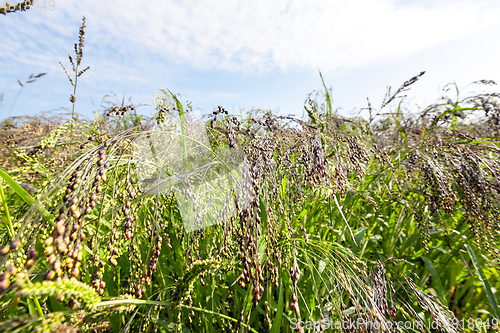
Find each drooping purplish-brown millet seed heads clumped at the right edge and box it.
[409,131,500,259]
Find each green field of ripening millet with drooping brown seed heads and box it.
[0,9,500,333]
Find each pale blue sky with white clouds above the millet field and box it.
[0,0,500,119]
